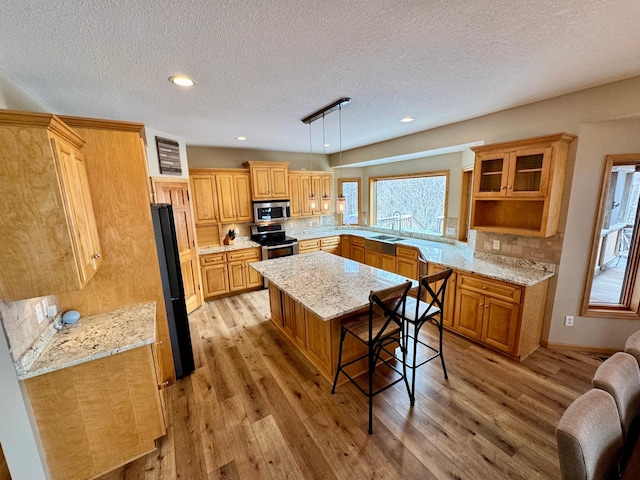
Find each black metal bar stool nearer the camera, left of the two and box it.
[331,281,411,434]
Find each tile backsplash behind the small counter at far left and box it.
[0,295,59,360]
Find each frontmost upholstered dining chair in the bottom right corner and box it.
[556,389,622,480]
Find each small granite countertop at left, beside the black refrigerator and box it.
[16,302,156,380]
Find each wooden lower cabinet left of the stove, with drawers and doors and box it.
[200,248,262,298]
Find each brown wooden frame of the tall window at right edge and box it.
[580,153,640,320]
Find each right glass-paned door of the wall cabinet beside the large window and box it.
[506,147,551,198]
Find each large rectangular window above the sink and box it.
[369,172,449,235]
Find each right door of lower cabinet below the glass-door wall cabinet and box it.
[482,297,519,353]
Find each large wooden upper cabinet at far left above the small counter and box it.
[0,110,102,301]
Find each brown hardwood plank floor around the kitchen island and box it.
[101,290,600,480]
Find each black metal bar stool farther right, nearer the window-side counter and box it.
[403,268,453,405]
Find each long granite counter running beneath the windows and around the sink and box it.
[292,228,555,287]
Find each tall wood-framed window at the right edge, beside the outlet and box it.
[582,154,640,319]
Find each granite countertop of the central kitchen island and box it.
[249,252,417,320]
